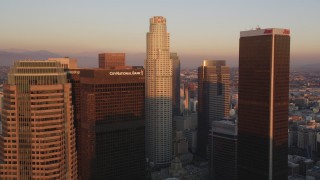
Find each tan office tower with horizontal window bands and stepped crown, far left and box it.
[0,60,77,180]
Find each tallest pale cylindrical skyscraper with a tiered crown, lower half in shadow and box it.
[145,16,173,166]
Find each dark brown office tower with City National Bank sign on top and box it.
[79,67,145,180]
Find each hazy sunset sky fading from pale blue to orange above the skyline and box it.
[0,0,320,64]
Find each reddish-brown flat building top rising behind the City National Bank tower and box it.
[99,53,126,69]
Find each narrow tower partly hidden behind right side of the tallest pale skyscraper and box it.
[170,53,181,115]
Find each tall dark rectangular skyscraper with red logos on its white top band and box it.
[238,28,290,180]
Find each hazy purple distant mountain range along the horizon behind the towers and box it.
[0,49,320,72]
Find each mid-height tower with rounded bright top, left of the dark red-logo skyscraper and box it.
[198,60,230,159]
